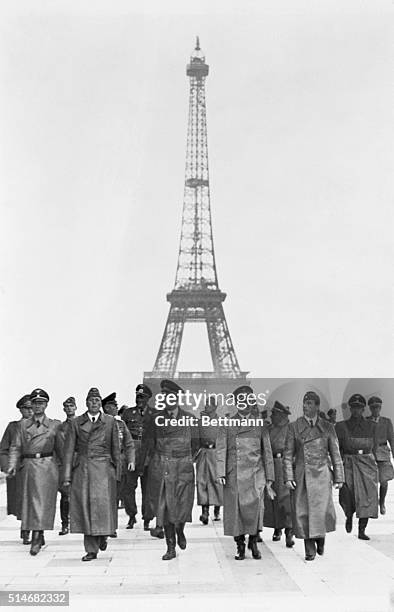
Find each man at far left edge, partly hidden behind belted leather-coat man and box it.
[0,395,33,544]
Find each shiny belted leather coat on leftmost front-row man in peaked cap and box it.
[8,415,62,531]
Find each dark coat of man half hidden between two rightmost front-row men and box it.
[264,423,292,529]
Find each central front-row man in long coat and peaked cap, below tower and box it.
[147,380,197,561]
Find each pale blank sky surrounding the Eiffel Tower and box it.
[0,0,394,421]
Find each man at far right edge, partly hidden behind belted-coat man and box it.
[367,396,394,514]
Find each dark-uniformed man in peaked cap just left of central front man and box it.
[122,384,154,531]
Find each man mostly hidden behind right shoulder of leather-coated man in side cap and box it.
[102,393,135,524]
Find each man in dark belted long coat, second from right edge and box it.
[336,393,379,540]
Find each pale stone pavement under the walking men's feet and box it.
[0,484,394,612]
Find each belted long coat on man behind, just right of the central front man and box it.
[196,411,223,506]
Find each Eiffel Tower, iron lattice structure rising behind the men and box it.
[151,37,246,378]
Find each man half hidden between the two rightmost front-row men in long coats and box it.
[264,401,294,548]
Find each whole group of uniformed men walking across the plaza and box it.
[0,380,394,561]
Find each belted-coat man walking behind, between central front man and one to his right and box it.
[196,397,223,525]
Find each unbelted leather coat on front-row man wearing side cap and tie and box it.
[63,412,120,536]
